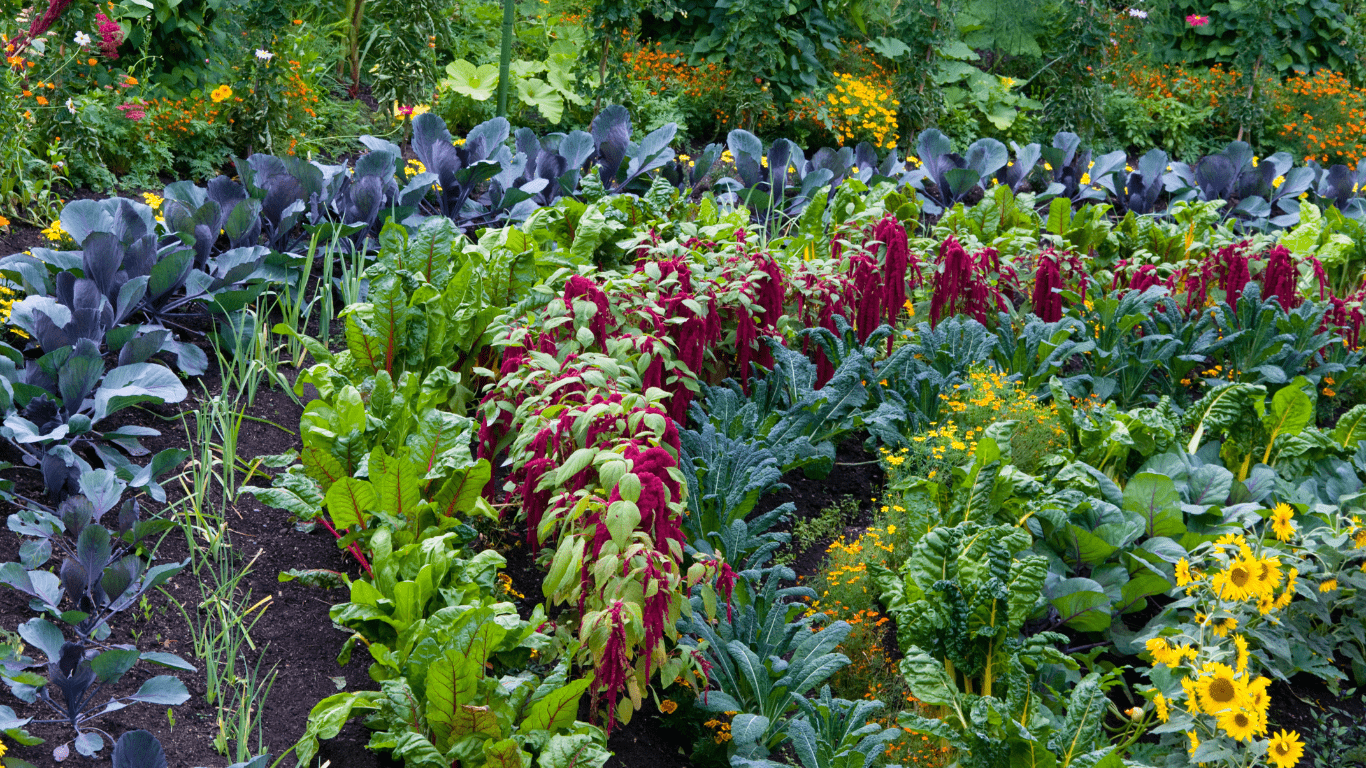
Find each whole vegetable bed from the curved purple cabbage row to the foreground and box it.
[0,3,1366,768]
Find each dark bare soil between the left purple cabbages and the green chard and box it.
[0,319,393,768]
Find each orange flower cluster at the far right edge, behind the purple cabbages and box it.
[1272,70,1366,167]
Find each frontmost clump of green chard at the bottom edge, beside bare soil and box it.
[304,532,608,768]
